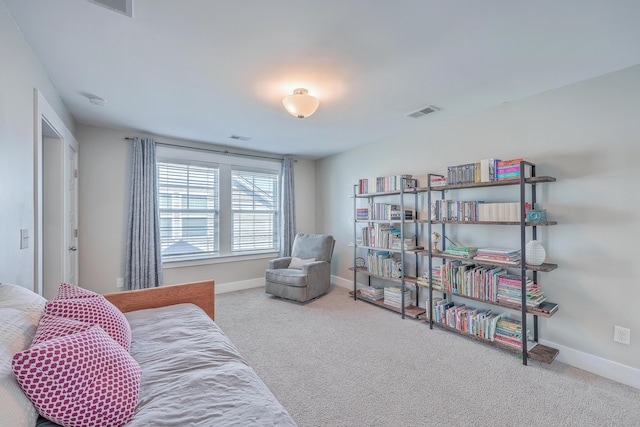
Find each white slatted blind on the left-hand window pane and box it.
[157,162,219,260]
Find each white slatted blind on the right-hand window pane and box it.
[231,170,279,253]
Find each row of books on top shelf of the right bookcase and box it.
[444,158,523,187]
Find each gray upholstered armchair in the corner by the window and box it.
[265,233,335,302]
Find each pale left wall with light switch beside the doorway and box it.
[0,2,75,289]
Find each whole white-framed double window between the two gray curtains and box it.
[157,147,280,261]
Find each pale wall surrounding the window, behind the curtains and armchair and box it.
[78,125,315,293]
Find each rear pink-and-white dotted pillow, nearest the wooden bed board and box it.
[44,295,131,351]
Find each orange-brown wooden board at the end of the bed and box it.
[104,280,215,320]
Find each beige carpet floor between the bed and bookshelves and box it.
[216,287,640,427]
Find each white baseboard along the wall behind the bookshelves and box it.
[331,276,640,389]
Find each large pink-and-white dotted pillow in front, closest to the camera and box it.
[12,326,142,427]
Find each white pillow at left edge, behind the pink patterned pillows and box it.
[0,283,46,426]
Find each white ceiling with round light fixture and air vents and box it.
[0,0,640,158]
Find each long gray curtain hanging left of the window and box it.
[124,138,162,289]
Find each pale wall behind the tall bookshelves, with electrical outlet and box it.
[316,66,640,387]
